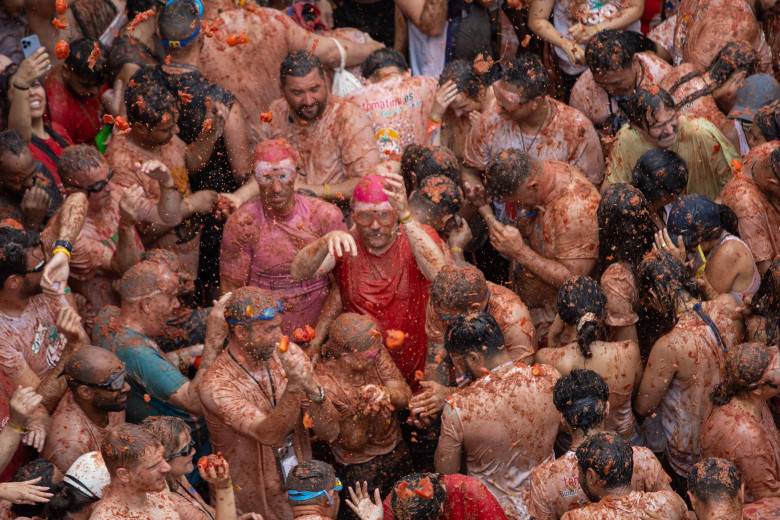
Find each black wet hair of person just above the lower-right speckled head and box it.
[553,368,609,433]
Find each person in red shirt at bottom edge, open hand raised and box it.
[347,473,507,520]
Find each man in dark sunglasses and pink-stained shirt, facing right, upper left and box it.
[57,144,146,324]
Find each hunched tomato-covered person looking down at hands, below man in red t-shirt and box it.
[317,313,413,495]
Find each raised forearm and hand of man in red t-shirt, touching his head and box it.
[382,173,446,281]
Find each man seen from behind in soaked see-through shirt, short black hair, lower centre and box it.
[436,312,560,519]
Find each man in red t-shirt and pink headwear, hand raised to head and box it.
[290,174,444,391]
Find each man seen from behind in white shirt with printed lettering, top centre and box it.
[346,49,436,153]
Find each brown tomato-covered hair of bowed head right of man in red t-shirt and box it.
[429,265,488,312]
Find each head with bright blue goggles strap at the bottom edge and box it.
[287,459,343,520]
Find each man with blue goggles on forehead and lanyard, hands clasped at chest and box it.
[200,287,338,520]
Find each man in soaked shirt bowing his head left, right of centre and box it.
[470,150,599,341]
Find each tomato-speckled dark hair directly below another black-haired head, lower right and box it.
[576,432,634,489]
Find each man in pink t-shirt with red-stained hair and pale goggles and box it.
[220,139,347,346]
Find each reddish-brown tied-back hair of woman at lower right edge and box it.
[710,343,774,406]
